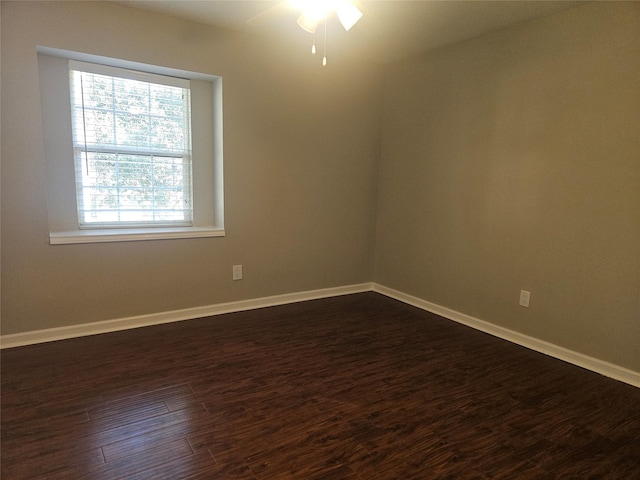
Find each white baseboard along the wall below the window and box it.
[0,283,373,349]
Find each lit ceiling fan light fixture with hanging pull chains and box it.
[290,0,362,65]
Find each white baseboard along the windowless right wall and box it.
[373,283,640,387]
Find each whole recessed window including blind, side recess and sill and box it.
[38,47,225,244]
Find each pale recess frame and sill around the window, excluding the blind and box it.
[38,47,225,245]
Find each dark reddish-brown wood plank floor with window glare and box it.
[1,293,640,480]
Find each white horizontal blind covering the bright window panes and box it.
[69,61,193,228]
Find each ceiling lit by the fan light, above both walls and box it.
[119,0,582,63]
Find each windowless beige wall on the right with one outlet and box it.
[374,2,640,371]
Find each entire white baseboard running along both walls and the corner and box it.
[0,283,640,388]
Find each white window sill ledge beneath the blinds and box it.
[49,227,225,245]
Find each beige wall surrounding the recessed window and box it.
[2,1,381,335]
